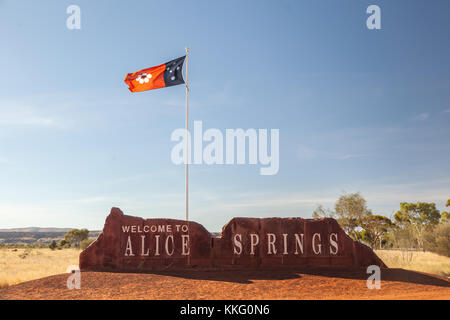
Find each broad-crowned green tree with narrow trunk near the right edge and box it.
[394,202,441,249]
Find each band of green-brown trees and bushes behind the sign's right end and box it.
[313,193,450,259]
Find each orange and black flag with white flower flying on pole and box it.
[125,56,186,92]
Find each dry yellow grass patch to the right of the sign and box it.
[375,250,450,277]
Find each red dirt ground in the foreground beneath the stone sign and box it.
[0,267,450,300]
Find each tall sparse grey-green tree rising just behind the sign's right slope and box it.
[334,192,371,239]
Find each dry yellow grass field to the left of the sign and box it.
[0,249,80,288]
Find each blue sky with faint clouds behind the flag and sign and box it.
[0,0,450,231]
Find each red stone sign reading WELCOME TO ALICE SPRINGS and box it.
[80,208,386,271]
